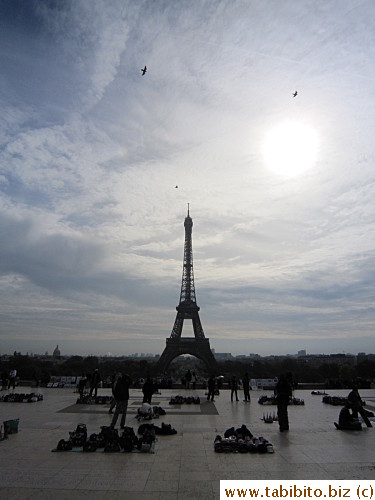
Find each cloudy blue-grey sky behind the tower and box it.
[0,0,375,355]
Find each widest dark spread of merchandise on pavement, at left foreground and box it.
[52,423,177,453]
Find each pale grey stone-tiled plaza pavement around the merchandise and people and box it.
[0,387,375,500]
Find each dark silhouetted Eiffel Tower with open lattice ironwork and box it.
[156,204,216,372]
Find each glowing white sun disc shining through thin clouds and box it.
[263,121,318,177]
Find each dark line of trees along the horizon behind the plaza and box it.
[0,353,375,387]
